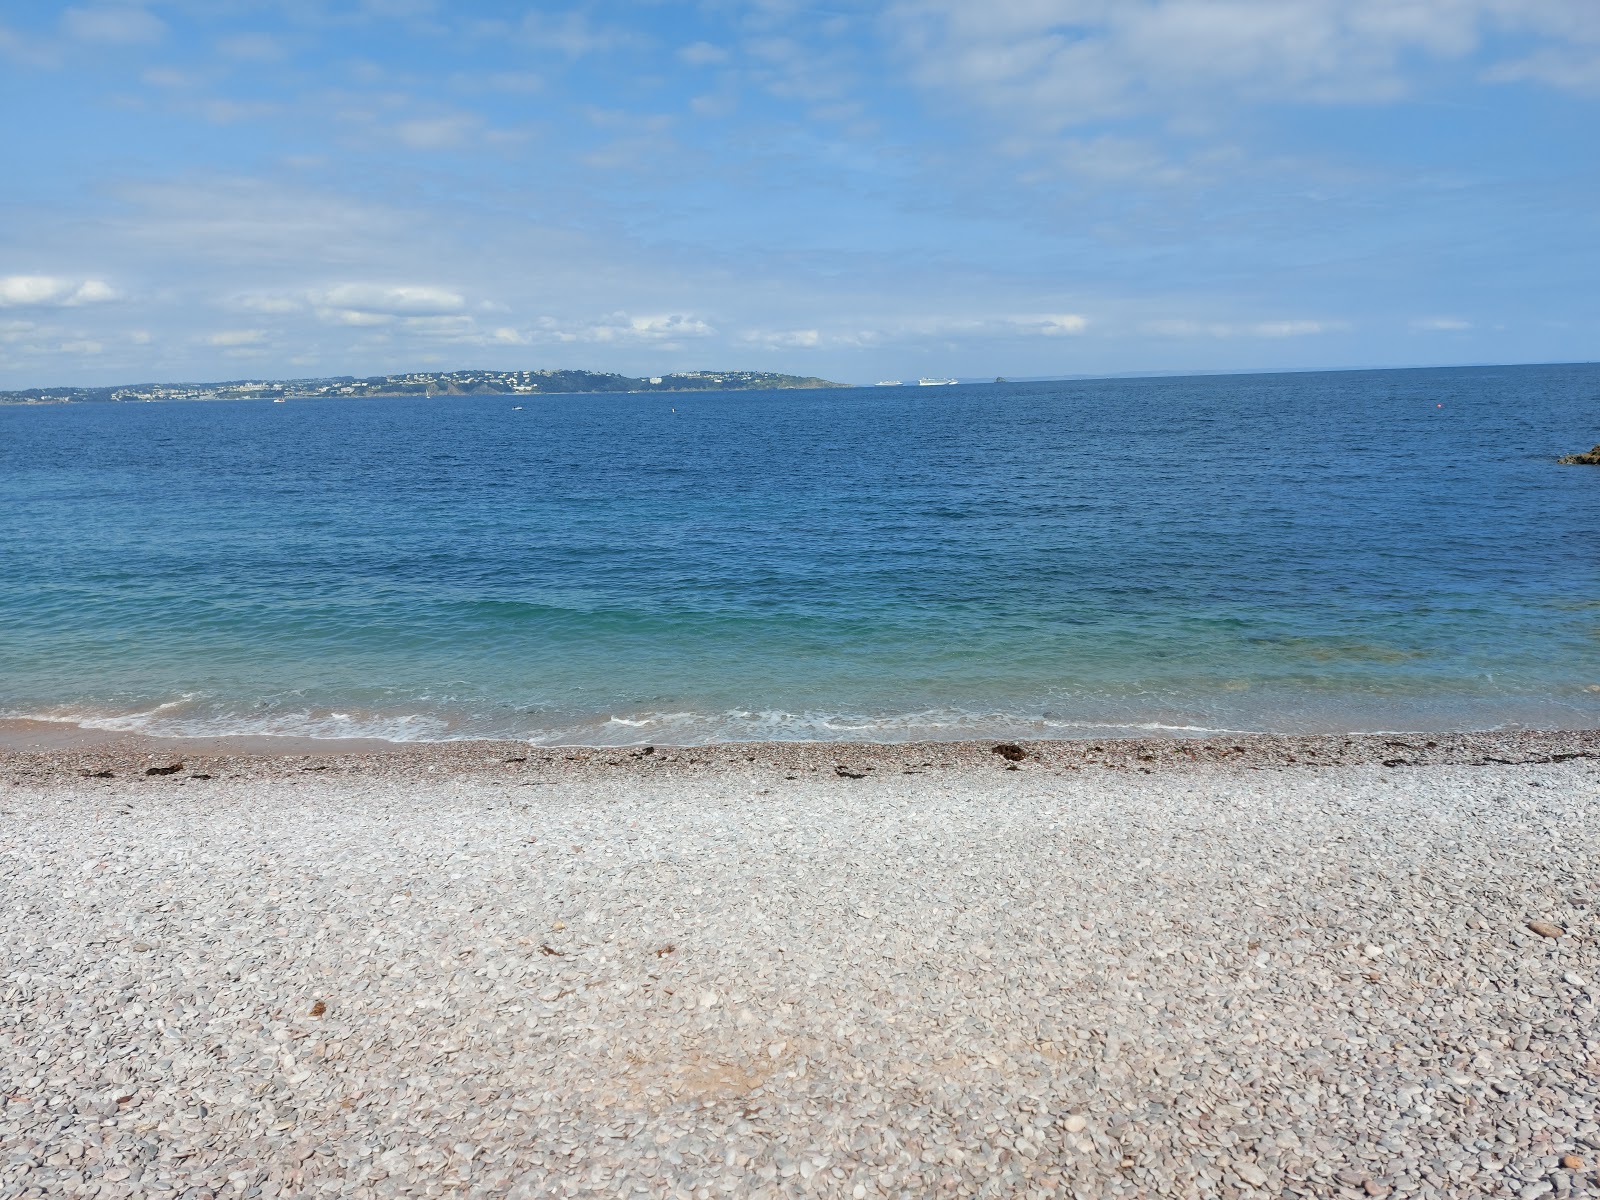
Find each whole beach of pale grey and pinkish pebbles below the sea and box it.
[0,733,1600,1200]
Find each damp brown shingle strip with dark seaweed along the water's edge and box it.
[0,720,1600,781]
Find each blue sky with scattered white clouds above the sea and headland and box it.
[0,0,1600,387]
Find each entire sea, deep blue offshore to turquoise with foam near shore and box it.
[0,366,1600,742]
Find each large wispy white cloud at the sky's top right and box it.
[885,0,1600,131]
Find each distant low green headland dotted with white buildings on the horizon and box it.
[0,371,848,405]
